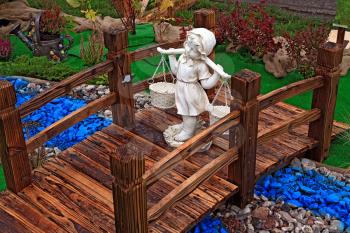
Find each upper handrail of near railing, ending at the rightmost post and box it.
[258,76,324,111]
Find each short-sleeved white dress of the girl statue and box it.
[175,55,211,116]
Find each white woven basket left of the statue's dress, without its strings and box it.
[149,82,175,109]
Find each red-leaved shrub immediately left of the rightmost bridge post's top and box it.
[284,26,329,78]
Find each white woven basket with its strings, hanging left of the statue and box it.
[149,54,175,109]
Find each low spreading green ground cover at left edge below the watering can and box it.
[0,55,77,81]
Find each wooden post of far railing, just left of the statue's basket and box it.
[104,30,135,129]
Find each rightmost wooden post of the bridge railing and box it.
[309,42,344,162]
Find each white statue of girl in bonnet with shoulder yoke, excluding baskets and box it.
[157,28,231,142]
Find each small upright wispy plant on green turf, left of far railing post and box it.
[80,30,104,66]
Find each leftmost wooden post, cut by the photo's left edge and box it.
[0,81,31,193]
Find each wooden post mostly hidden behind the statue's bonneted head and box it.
[193,9,216,98]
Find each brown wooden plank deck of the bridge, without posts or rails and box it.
[0,103,348,233]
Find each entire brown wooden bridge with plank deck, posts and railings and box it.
[0,11,349,233]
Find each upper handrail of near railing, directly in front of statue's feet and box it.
[143,111,240,186]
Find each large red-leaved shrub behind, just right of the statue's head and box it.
[216,2,281,58]
